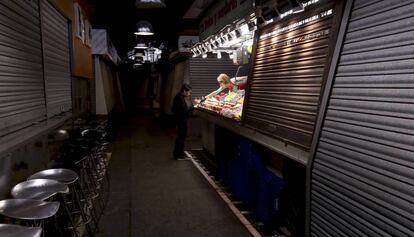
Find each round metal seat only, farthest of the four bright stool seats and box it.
[29,169,79,184]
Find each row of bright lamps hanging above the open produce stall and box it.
[191,20,256,58]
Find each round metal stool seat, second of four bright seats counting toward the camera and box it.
[11,179,69,201]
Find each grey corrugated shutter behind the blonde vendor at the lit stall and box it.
[189,58,237,98]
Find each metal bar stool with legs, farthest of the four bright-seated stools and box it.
[28,169,98,236]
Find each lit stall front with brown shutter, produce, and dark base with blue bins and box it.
[192,0,344,236]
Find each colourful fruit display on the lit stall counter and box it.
[196,90,245,121]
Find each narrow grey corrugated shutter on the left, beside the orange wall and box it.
[41,0,72,117]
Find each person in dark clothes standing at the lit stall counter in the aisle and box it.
[172,84,193,160]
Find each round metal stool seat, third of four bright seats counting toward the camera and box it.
[0,199,59,220]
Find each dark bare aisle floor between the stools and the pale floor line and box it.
[98,117,250,237]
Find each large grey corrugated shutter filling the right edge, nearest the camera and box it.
[310,0,414,236]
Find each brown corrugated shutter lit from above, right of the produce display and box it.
[244,1,339,149]
